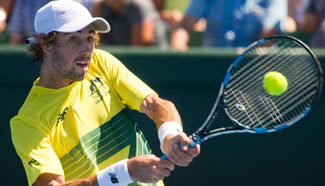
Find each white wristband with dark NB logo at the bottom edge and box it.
[97,159,133,186]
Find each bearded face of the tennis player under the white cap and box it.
[51,25,95,82]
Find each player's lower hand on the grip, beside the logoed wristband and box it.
[127,155,175,183]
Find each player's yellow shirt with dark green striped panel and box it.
[10,49,162,185]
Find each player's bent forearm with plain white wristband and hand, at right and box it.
[140,94,200,166]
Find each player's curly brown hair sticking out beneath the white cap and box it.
[27,32,100,63]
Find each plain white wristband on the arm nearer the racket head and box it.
[158,121,183,152]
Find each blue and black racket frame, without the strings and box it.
[190,35,323,146]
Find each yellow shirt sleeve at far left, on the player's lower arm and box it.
[10,117,64,185]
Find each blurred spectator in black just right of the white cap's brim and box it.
[93,0,168,48]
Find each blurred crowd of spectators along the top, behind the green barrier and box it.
[0,0,325,51]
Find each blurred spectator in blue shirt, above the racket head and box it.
[171,0,287,50]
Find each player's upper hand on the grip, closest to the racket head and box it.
[163,133,200,166]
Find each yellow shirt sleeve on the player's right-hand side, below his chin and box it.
[91,50,157,111]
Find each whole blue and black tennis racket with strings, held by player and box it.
[162,36,322,159]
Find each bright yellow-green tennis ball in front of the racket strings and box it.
[263,71,288,96]
